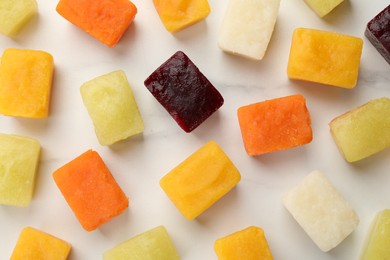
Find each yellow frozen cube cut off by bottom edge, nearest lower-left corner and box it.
[10,227,71,260]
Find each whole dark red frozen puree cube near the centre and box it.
[145,51,223,133]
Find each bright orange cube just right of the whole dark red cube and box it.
[237,95,313,156]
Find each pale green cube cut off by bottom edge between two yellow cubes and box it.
[103,226,180,260]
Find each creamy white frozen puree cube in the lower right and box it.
[283,171,359,252]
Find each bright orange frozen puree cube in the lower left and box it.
[53,150,129,231]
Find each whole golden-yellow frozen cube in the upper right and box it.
[287,28,363,89]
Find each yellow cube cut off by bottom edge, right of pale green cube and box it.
[214,226,273,260]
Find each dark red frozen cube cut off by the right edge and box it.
[364,5,390,64]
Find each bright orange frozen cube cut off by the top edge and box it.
[56,0,137,47]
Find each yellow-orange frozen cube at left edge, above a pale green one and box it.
[0,49,54,118]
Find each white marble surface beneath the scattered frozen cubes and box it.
[0,0,390,260]
